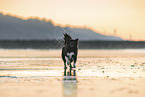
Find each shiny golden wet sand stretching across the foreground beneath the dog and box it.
[0,49,145,97]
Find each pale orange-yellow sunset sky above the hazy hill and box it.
[0,0,145,41]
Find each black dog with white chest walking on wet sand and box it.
[62,33,78,69]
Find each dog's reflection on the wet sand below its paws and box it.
[63,69,77,97]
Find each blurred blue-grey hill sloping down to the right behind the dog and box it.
[0,13,123,41]
